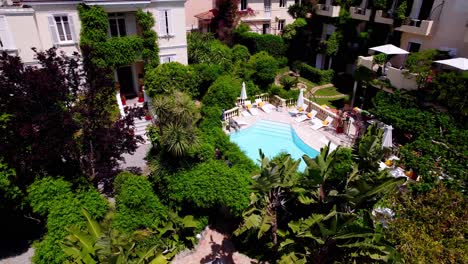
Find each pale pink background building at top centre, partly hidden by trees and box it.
[185,0,295,35]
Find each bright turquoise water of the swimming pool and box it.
[230,120,319,171]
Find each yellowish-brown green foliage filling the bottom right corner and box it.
[386,185,468,263]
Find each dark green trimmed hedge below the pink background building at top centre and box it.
[235,31,287,57]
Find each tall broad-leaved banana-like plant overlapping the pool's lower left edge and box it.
[234,150,300,246]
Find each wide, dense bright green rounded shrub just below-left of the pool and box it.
[168,160,250,215]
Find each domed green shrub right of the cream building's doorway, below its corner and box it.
[145,62,197,97]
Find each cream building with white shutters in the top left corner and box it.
[0,0,187,94]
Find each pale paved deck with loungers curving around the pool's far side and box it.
[226,104,356,151]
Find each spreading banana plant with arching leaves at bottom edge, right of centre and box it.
[279,207,393,263]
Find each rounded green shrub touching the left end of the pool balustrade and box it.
[203,75,242,109]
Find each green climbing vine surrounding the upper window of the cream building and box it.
[78,4,159,68]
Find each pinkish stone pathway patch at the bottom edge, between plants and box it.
[171,227,258,264]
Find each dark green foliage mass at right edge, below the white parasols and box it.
[372,92,468,190]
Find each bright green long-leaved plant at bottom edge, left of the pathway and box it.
[61,209,197,264]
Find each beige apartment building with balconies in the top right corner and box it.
[350,0,468,89]
